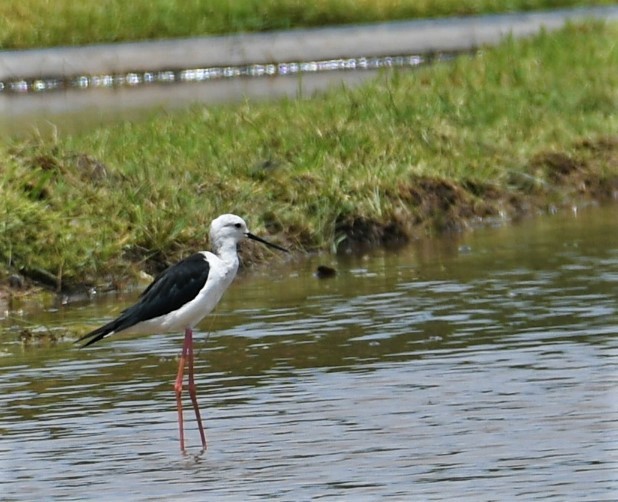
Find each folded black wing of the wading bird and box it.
[77,253,210,347]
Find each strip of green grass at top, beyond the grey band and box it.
[0,0,615,49]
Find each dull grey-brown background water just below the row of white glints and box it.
[0,70,379,137]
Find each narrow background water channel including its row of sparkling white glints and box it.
[0,52,440,137]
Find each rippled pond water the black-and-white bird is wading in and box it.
[0,206,618,501]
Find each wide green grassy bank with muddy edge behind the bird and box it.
[0,24,618,287]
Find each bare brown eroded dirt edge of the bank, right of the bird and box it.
[337,136,618,251]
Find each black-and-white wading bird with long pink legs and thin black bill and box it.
[76,214,289,452]
